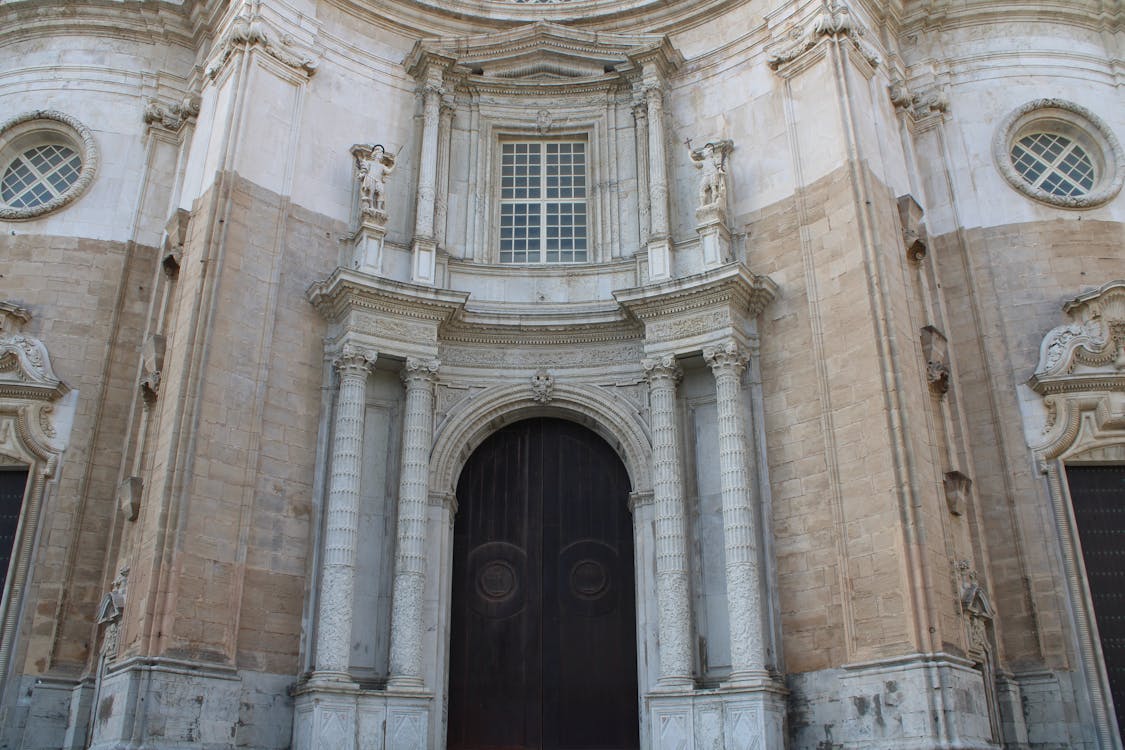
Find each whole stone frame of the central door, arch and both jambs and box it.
[429,383,656,747]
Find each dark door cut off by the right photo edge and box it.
[1067,466,1125,731]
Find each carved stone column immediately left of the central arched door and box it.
[388,358,441,689]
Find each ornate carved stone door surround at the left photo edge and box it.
[0,302,75,699]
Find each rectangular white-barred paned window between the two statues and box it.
[500,141,587,263]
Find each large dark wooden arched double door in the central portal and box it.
[448,418,639,750]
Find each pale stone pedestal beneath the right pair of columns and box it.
[646,679,785,750]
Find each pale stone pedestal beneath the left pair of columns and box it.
[293,688,429,750]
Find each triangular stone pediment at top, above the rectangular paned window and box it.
[404,21,683,88]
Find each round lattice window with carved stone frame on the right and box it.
[992,99,1125,208]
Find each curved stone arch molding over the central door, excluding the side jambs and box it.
[430,385,653,495]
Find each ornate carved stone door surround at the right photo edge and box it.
[1028,280,1125,748]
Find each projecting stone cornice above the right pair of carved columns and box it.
[613,262,777,320]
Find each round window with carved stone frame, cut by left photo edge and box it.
[0,110,98,220]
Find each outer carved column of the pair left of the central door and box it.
[313,344,376,684]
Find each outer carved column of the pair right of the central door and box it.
[703,342,768,684]
